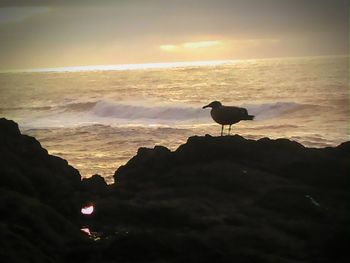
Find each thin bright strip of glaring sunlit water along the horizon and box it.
[0,54,349,73]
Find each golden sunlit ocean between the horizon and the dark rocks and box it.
[0,56,349,182]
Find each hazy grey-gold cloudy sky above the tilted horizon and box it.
[0,0,349,70]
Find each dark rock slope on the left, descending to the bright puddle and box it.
[0,118,87,263]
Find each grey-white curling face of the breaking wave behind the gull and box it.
[60,100,312,121]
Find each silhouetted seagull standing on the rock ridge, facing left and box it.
[203,101,254,136]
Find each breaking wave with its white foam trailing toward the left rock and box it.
[21,100,311,128]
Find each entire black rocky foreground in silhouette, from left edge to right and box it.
[0,119,350,262]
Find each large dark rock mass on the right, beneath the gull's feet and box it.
[106,135,350,262]
